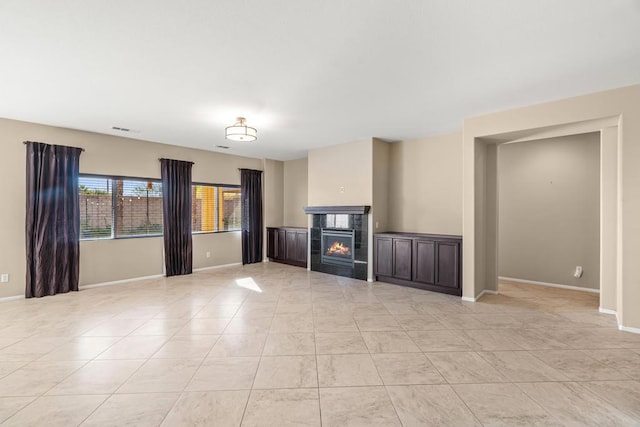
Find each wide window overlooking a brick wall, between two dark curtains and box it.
[79,175,162,239]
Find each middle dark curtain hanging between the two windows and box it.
[160,159,193,276]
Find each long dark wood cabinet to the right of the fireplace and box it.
[374,233,462,295]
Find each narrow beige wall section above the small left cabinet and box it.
[283,157,308,227]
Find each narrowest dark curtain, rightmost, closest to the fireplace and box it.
[240,169,263,265]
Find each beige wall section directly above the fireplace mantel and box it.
[308,138,373,206]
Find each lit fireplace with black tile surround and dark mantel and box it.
[305,206,370,280]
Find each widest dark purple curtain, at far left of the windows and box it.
[25,141,82,298]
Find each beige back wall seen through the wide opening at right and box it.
[498,133,600,289]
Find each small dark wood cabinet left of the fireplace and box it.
[267,227,307,267]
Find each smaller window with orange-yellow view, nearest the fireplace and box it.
[191,184,241,233]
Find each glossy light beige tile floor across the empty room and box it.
[0,263,640,426]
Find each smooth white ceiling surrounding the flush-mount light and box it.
[0,0,640,160]
